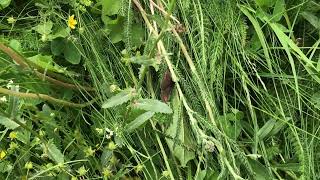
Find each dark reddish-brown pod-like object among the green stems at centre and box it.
[161,70,174,102]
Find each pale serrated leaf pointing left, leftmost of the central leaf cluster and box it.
[102,88,136,108]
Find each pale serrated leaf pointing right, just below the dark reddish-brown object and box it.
[134,99,172,114]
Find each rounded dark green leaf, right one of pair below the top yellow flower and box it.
[63,41,81,64]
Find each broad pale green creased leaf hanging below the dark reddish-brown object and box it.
[166,94,195,167]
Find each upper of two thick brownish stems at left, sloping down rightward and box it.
[0,43,95,91]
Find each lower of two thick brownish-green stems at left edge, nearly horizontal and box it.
[0,87,95,108]
